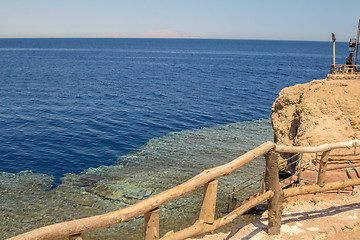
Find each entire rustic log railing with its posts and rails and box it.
[10,140,360,240]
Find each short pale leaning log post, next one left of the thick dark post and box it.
[199,180,218,224]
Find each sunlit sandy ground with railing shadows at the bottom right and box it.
[190,165,360,240]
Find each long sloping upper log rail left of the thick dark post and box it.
[10,142,275,240]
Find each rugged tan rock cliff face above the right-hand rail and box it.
[271,79,360,146]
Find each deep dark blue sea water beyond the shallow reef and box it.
[0,39,347,178]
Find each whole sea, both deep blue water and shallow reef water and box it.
[0,38,347,239]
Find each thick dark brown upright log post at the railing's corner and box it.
[265,150,284,235]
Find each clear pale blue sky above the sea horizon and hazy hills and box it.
[0,0,360,42]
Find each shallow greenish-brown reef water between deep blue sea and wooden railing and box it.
[0,120,273,239]
